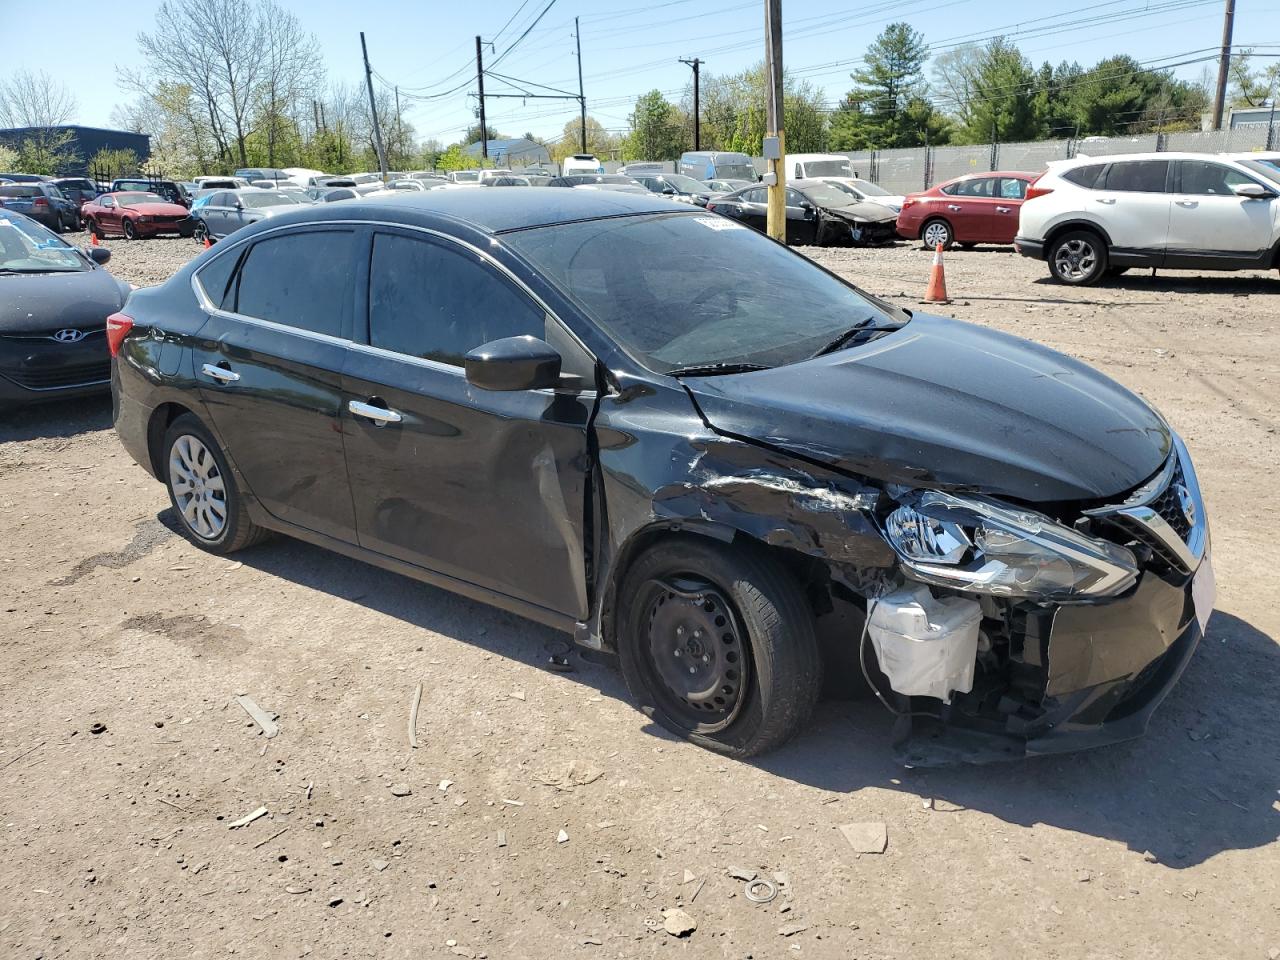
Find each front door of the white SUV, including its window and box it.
[1166,160,1280,266]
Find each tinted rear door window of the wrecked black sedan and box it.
[233,230,356,337]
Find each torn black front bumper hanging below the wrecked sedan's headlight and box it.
[896,550,1215,767]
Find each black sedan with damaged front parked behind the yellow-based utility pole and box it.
[707,180,897,247]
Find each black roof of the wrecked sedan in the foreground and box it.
[236,187,690,233]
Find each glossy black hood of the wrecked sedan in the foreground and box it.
[684,315,1171,503]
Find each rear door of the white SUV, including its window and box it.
[1085,160,1172,256]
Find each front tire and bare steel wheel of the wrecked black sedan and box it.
[617,536,822,756]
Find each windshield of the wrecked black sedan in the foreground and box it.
[504,214,899,372]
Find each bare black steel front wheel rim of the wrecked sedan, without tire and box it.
[641,577,751,733]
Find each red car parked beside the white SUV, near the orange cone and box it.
[897,170,1039,250]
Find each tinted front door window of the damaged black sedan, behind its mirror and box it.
[369,233,547,366]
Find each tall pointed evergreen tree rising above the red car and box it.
[831,23,948,150]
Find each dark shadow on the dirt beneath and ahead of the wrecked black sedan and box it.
[160,511,1280,868]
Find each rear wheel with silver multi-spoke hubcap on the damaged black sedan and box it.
[160,413,266,554]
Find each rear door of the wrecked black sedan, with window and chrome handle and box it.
[193,225,367,543]
